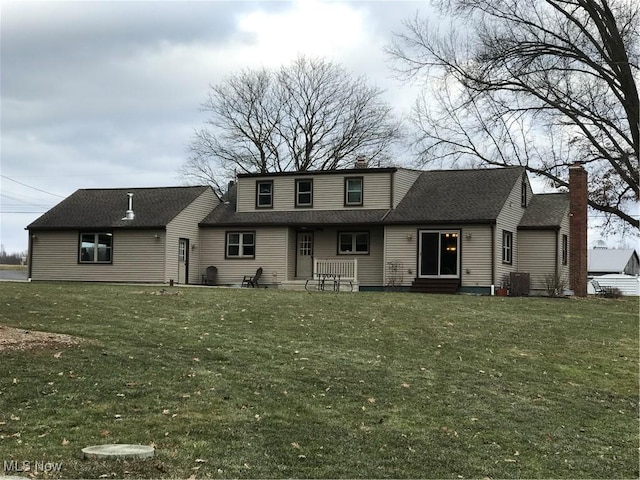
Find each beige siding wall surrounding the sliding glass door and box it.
[384,225,491,287]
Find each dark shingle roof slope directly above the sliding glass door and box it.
[385,167,525,223]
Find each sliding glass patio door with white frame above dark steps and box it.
[418,230,460,278]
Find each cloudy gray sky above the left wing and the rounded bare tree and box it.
[0,0,440,252]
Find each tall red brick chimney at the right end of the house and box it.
[569,162,588,297]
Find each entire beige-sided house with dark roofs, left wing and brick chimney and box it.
[28,164,586,294]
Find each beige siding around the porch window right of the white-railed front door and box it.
[313,226,384,287]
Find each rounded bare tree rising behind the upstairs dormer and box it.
[181,57,400,192]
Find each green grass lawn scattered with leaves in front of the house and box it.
[0,283,639,478]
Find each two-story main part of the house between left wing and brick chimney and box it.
[200,167,569,293]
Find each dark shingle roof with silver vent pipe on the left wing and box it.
[27,186,210,230]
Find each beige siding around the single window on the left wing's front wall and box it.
[31,230,165,283]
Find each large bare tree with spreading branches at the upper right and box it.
[388,0,640,228]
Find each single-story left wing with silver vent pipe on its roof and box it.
[27,186,218,283]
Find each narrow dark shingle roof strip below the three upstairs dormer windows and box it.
[200,203,388,227]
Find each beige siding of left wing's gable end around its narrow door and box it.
[164,189,219,284]
